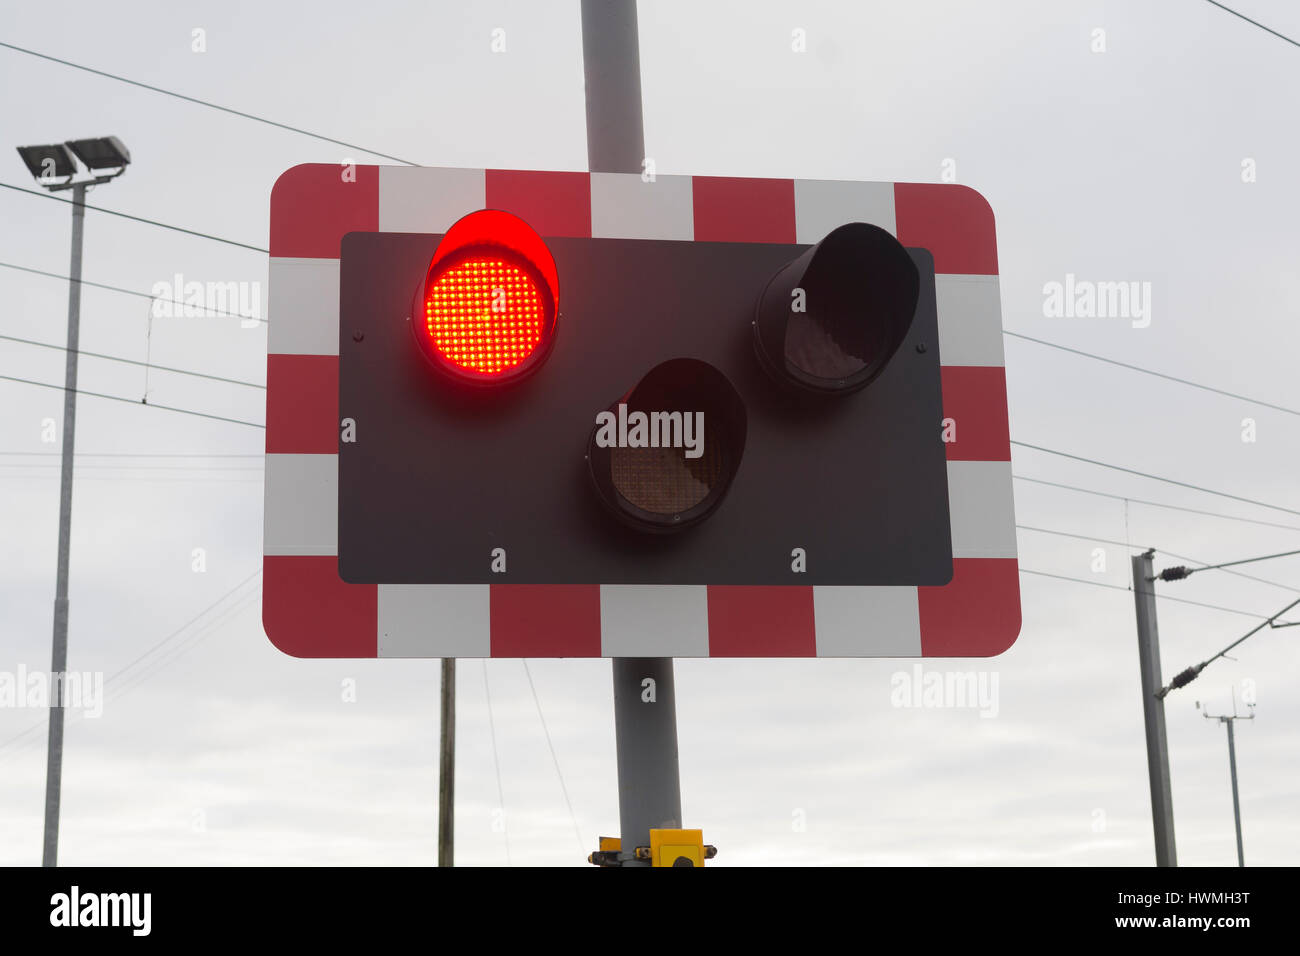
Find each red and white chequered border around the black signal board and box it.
[263,164,1021,657]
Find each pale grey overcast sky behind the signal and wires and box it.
[0,0,1300,865]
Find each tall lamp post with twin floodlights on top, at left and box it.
[18,137,131,866]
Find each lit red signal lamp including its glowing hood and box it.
[413,209,558,384]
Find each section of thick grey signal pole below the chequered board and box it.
[614,657,681,866]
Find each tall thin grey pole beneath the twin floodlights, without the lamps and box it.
[40,183,86,866]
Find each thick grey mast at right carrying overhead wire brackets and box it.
[1132,551,1178,866]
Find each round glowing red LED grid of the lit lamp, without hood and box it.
[425,255,546,375]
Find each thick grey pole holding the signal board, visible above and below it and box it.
[582,0,681,866]
